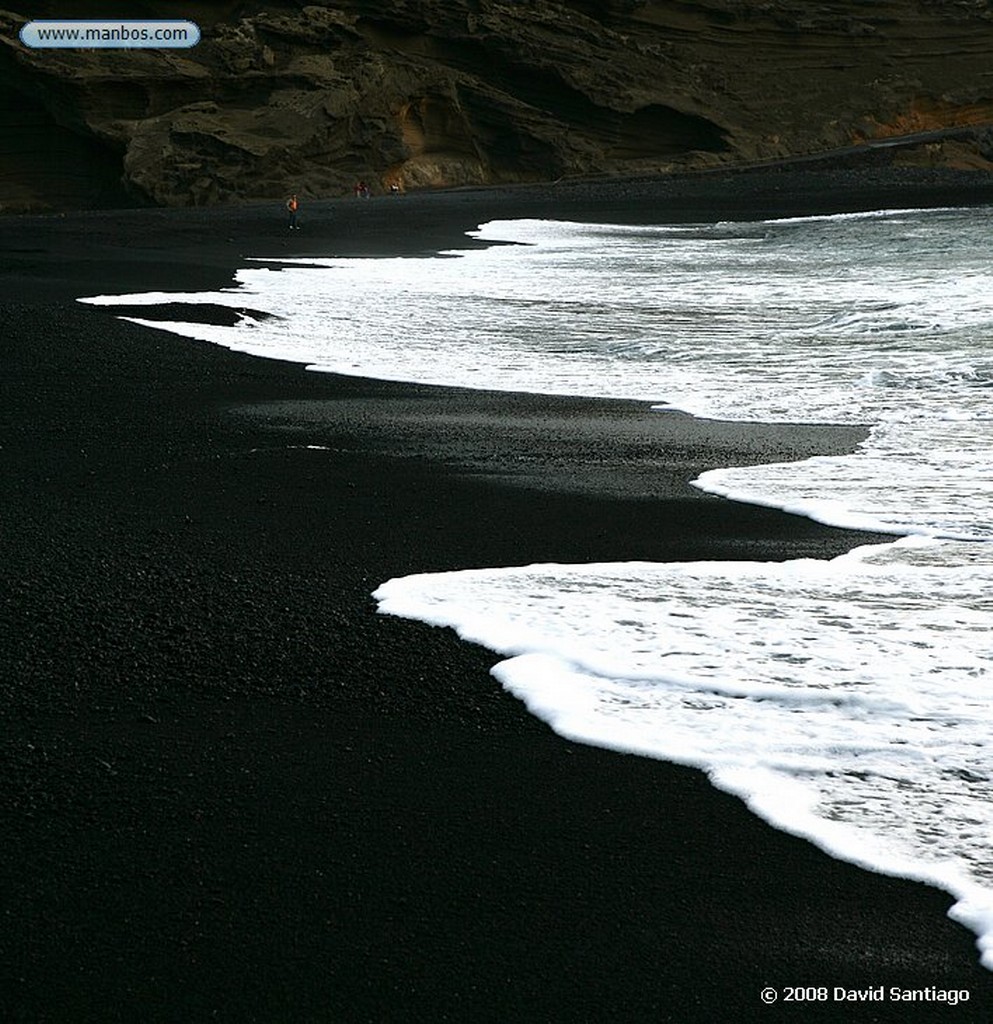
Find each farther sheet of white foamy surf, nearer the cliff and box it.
[84,210,993,538]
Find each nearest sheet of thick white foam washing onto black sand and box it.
[374,541,993,968]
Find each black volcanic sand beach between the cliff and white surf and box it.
[0,168,993,1024]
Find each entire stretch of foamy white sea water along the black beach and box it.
[84,208,993,969]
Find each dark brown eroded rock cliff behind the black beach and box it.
[0,0,993,209]
